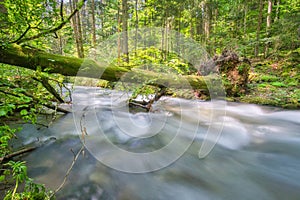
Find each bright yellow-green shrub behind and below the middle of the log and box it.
[112,47,195,99]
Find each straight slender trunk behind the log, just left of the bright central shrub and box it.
[122,0,129,63]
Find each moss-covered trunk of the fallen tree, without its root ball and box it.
[0,44,220,90]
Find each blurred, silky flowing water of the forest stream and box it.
[16,87,300,200]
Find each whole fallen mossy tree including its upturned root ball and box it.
[0,44,250,100]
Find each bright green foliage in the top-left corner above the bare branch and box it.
[0,0,59,42]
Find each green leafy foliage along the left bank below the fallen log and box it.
[0,64,62,200]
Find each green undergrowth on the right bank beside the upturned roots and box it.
[238,52,300,109]
